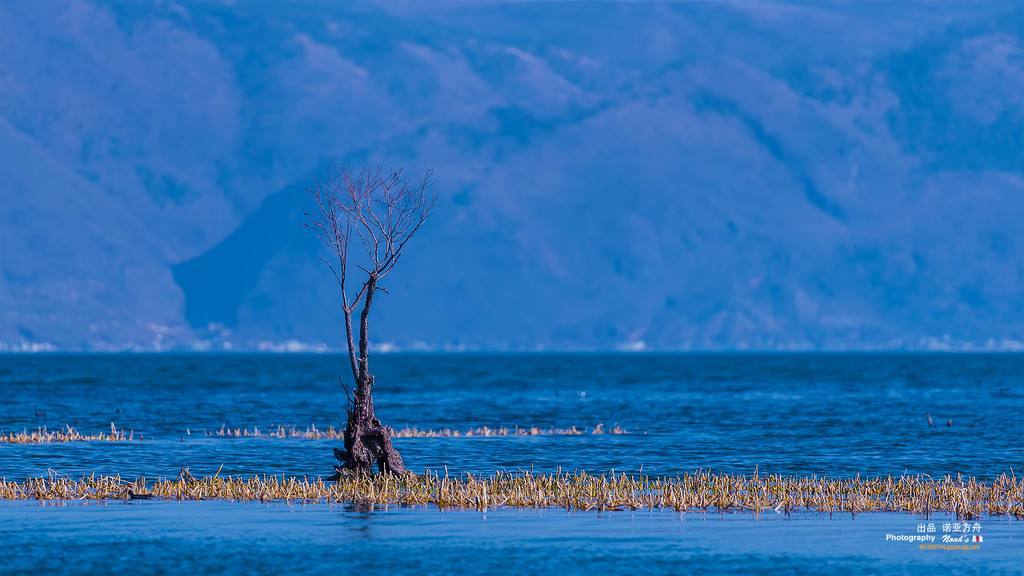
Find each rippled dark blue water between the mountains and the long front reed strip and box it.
[0,355,1024,478]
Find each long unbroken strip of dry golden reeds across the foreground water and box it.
[0,470,1024,519]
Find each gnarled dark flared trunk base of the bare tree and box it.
[330,373,409,480]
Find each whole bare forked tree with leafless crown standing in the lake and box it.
[306,166,437,480]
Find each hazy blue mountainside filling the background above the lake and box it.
[0,0,1024,351]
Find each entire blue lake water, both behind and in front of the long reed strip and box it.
[0,355,1024,573]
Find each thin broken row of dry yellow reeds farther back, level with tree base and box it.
[0,422,628,444]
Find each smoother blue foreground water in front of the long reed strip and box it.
[0,501,1024,574]
